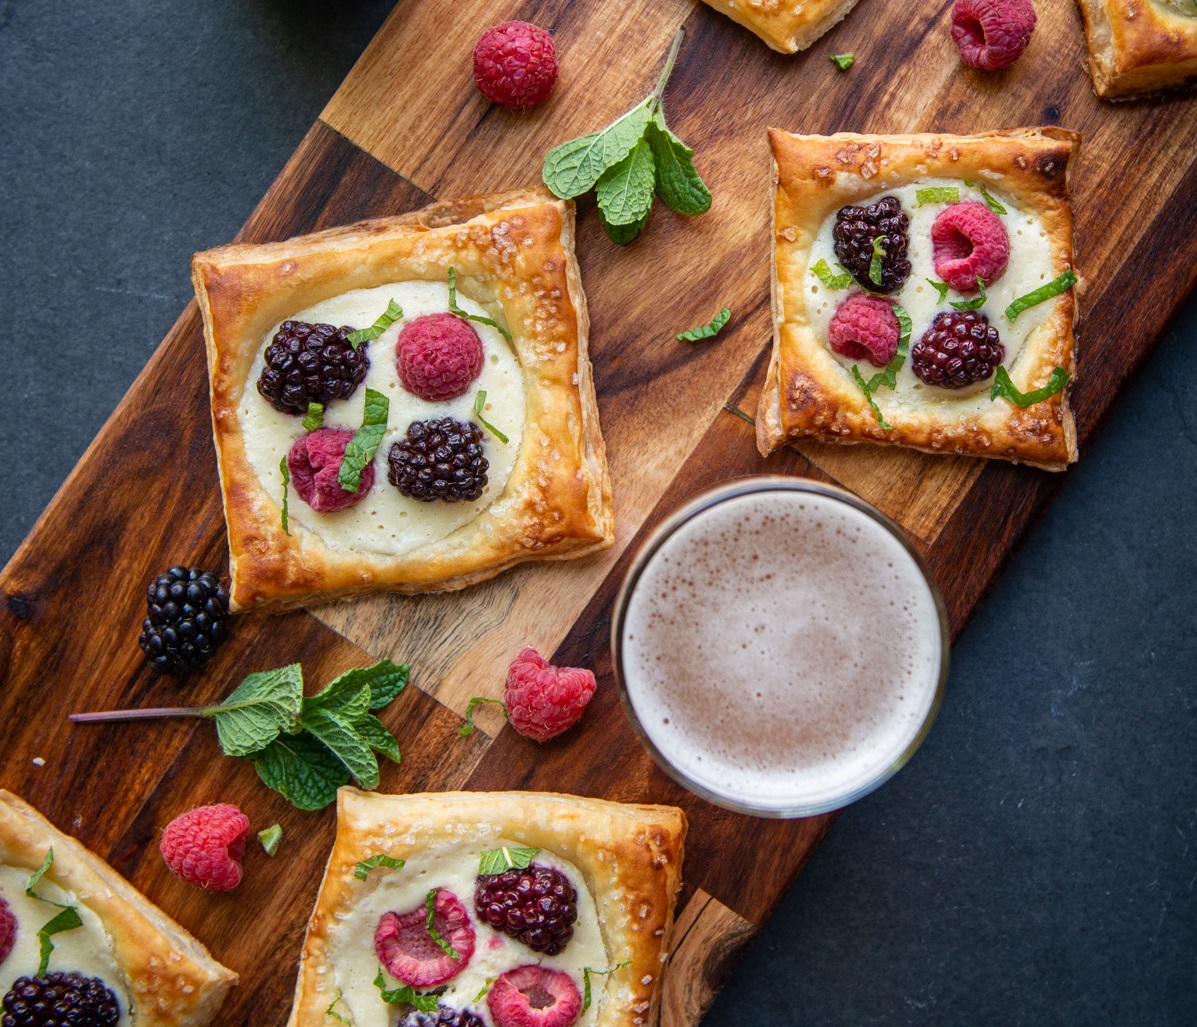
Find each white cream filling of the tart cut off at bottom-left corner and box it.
[0,865,133,1027]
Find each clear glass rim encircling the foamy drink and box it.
[610,475,952,820]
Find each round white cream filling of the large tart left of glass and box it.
[238,281,524,555]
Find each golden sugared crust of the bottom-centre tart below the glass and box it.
[288,788,686,1027]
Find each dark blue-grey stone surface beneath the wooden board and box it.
[0,0,1197,1027]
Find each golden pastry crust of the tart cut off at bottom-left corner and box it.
[0,790,237,1027]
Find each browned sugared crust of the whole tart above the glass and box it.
[757,128,1080,470]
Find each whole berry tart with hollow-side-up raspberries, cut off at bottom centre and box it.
[288,788,686,1027]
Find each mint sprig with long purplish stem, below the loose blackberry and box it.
[71,660,408,809]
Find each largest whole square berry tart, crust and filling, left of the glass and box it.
[192,189,614,609]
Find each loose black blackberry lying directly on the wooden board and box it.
[138,567,229,676]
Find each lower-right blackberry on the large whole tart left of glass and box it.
[387,418,491,503]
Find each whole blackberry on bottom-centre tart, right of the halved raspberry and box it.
[474,863,578,955]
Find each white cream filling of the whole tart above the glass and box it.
[804,178,1056,417]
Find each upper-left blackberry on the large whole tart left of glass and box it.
[257,321,370,414]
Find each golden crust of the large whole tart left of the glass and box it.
[192,189,614,610]
